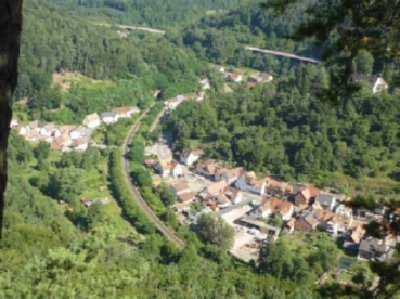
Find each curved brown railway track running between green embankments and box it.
[121,108,185,249]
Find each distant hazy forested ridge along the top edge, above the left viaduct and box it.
[48,0,242,28]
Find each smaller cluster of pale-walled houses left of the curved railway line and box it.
[11,106,140,153]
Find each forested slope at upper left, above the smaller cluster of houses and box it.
[15,0,203,119]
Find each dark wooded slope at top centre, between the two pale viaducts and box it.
[171,1,319,69]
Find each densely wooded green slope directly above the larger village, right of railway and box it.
[165,65,400,196]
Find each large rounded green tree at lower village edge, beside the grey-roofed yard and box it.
[197,213,234,250]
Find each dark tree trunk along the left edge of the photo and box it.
[0,0,22,237]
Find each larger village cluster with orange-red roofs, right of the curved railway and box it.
[144,143,400,262]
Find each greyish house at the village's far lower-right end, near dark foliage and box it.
[358,237,393,261]
